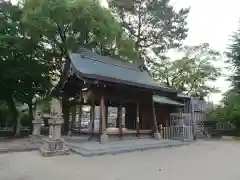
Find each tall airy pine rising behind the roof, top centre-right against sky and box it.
[108,0,189,63]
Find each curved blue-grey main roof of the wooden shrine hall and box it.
[70,49,176,92]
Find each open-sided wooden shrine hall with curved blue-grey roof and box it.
[64,48,182,143]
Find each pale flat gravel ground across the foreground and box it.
[0,141,240,180]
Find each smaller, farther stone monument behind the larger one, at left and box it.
[28,115,43,143]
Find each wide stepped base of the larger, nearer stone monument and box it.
[40,139,70,156]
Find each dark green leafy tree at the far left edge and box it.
[0,2,51,135]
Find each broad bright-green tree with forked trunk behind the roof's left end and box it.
[24,0,140,132]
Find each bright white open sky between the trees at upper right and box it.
[172,0,240,103]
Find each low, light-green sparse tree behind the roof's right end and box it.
[152,44,221,96]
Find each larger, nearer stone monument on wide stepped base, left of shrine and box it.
[40,115,70,156]
